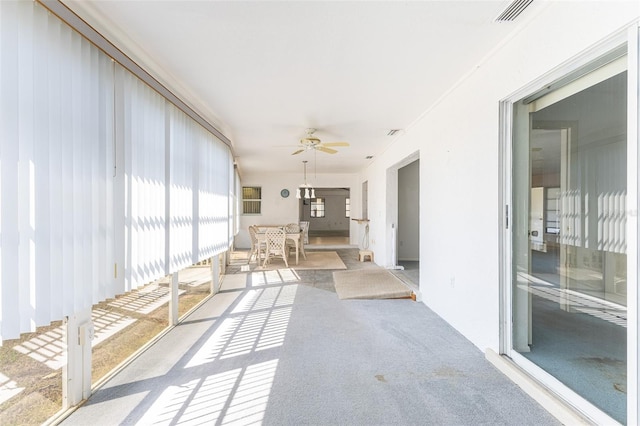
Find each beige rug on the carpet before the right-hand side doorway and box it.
[333,269,412,299]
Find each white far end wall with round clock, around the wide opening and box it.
[235,173,362,248]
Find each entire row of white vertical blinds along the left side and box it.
[0,1,235,343]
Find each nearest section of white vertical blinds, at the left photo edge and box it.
[0,1,114,340]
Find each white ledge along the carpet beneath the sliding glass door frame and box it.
[485,349,594,425]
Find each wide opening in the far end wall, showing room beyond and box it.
[299,188,351,245]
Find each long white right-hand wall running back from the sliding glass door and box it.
[353,1,639,351]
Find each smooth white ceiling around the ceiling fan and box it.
[64,0,531,173]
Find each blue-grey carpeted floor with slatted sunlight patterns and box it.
[63,248,558,425]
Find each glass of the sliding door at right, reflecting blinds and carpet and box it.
[511,65,627,423]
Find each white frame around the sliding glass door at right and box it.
[498,22,640,424]
